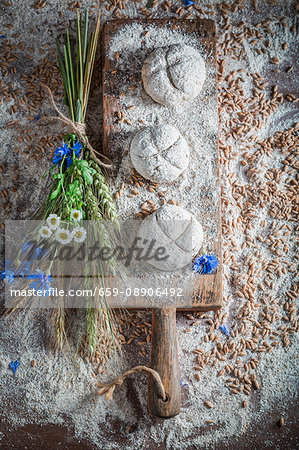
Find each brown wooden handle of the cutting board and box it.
[148,308,181,419]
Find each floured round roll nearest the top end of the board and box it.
[142,44,206,106]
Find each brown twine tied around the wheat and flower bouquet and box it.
[42,84,112,169]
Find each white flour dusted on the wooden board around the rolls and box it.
[108,23,219,251]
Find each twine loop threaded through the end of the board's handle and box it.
[98,366,167,401]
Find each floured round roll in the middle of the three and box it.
[130,124,189,183]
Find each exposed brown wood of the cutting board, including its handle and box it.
[102,19,222,418]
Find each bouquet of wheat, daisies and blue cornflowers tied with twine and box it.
[2,11,117,357]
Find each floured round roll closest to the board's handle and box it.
[138,205,203,271]
